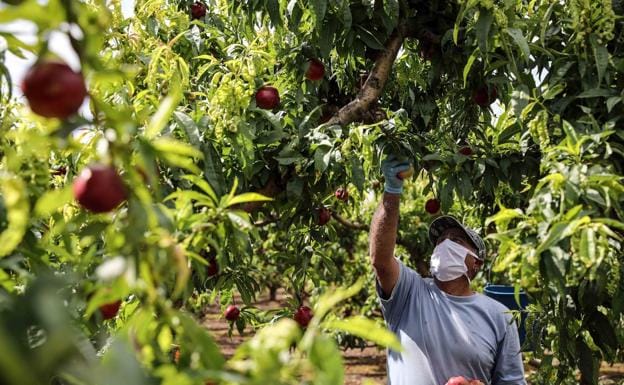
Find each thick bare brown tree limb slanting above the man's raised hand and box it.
[327,27,404,126]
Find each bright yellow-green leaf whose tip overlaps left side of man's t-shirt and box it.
[323,317,402,352]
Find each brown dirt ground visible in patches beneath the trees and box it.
[203,293,624,385]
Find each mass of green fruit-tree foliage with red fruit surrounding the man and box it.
[0,0,624,384]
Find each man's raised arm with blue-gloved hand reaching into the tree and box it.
[369,156,411,296]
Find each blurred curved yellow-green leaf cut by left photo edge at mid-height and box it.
[0,174,30,257]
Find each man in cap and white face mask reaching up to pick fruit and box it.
[370,156,526,385]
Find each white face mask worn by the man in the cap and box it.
[431,239,477,282]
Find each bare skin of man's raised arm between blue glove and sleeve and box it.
[369,193,400,294]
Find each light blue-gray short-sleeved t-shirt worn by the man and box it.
[377,260,526,385]
